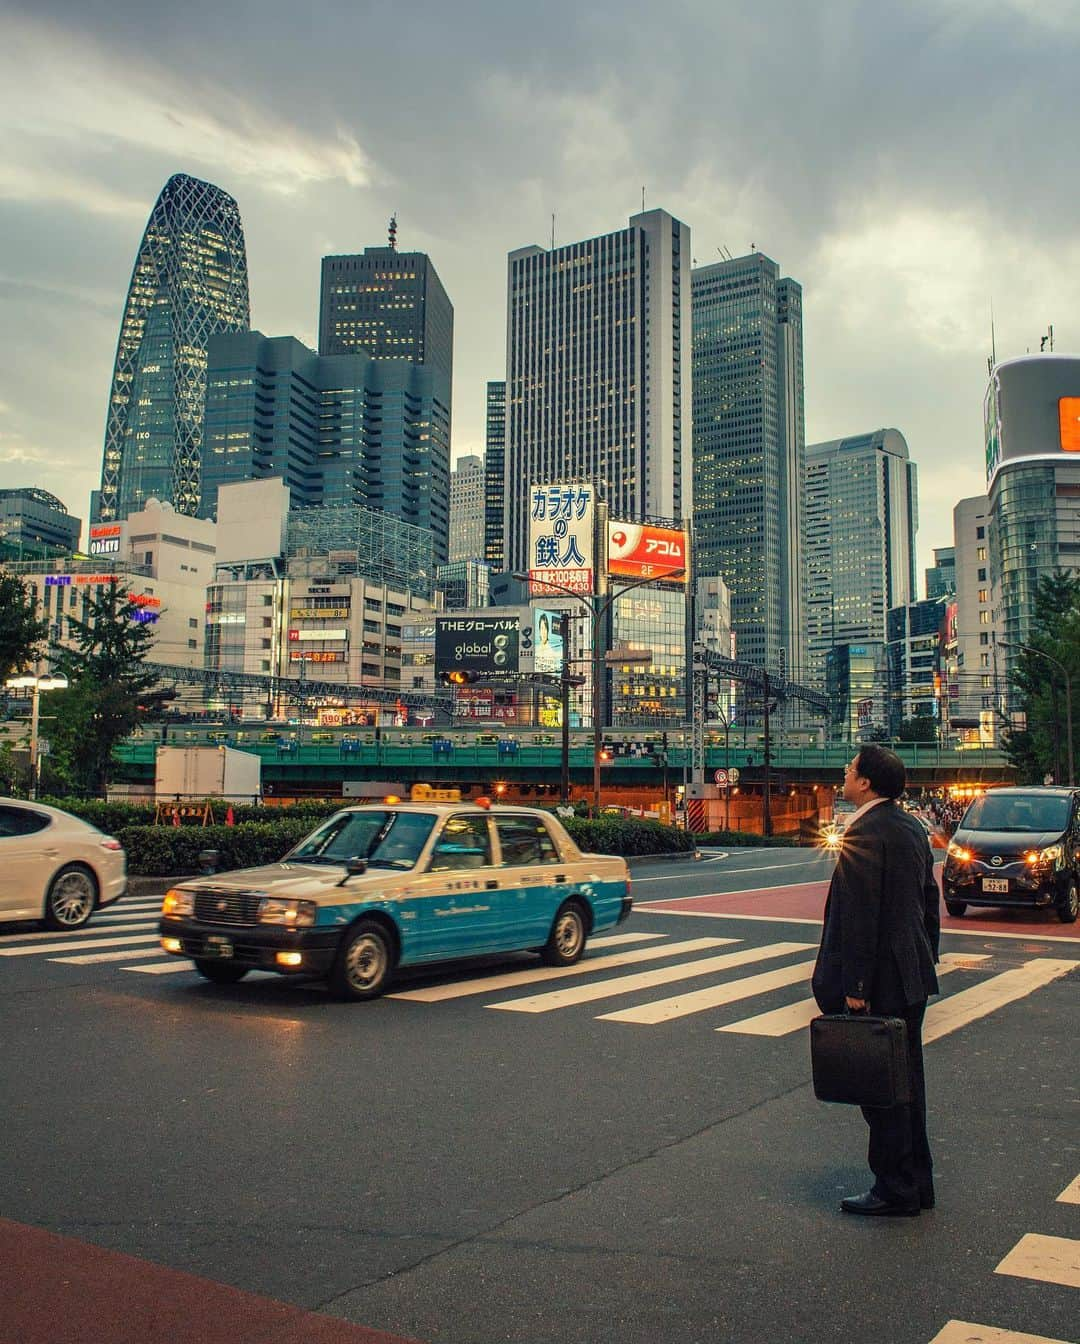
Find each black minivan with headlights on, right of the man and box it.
[942,788,1080,923]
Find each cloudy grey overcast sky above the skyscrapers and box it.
[0,0,1080,577]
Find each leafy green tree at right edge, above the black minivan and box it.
[1005,570,1080,784]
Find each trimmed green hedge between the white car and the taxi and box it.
[124,818,312,878]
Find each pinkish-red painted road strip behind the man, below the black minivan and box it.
[634,882,1080,942]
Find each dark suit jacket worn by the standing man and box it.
[813,801,940,1012]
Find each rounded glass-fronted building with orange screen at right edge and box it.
[983,355,1080,680]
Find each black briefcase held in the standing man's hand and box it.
[810,1013,911,1106]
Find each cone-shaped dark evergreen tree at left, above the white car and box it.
[42,581,157,794]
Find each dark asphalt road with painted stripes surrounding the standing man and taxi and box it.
[0,849,1080,1344]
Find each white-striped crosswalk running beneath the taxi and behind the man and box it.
[8,898,1080,1042]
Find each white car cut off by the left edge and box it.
[0,798,128,929]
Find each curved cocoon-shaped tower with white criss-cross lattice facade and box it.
[94,173,250,521]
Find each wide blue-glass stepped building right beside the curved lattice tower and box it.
[200,332,450,563]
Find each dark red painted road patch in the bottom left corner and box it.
[0,1218,416,1344]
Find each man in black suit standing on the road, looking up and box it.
[813,745,940,1216]
